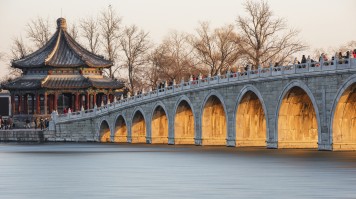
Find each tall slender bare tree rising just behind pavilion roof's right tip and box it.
[99,6,121,78]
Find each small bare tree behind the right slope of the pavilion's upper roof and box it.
[80,17,100,54]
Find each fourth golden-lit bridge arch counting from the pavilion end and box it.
[151,101,169,144]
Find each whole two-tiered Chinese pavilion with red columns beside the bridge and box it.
[3,18,124,117]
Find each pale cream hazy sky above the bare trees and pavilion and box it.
[0,0,356,78]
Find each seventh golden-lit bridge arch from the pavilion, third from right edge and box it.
[233,85,269,146]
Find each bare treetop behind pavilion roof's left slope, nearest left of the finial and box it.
[27,17,52,48]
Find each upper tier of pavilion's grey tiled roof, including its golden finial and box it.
[12,18,113,69]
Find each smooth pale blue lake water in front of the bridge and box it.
[0,143,356,199]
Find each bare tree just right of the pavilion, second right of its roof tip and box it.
[120,25,151,93]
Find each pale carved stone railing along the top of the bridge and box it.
[52,58,356,122]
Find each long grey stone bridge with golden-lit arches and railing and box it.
[47,58,356,150]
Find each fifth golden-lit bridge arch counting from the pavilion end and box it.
[173,95,196,144]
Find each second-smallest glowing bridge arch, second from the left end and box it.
[113,113,128,142]
